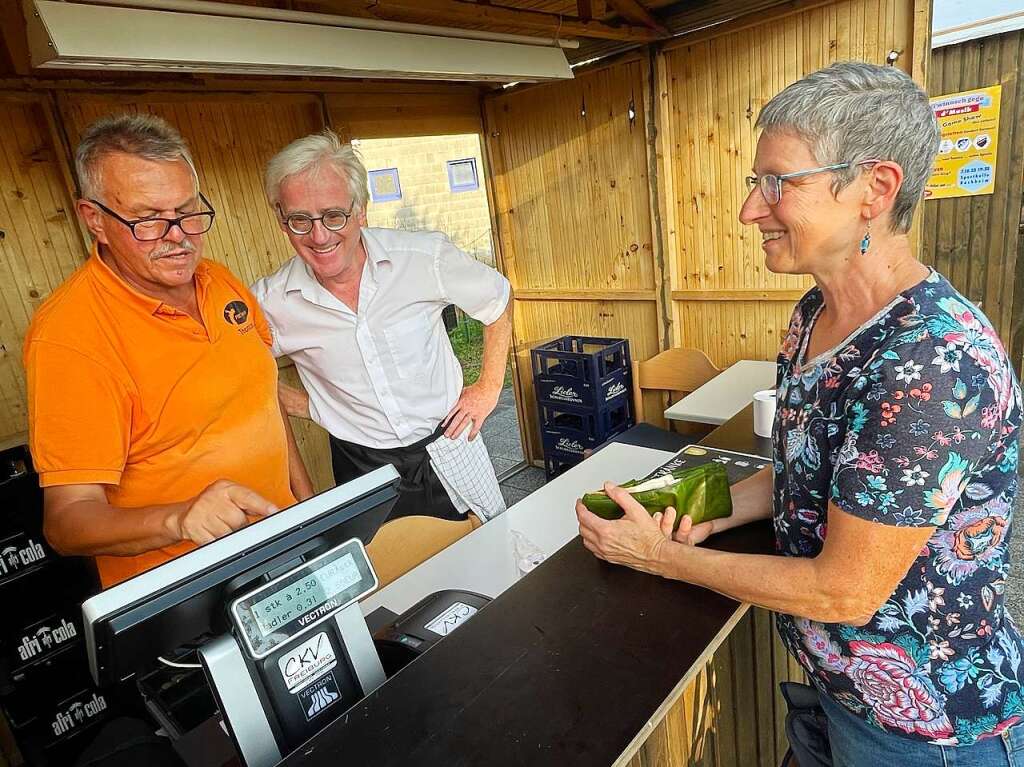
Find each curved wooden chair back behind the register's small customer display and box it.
[367,514,480,588]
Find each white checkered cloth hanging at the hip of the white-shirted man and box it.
[427,428,506,521]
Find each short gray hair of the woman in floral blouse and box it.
[757,61,940,232]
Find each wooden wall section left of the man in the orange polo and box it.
[0,93,85,448]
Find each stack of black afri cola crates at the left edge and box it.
[0,448,113,767]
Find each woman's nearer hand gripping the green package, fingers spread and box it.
[577,482,676,574]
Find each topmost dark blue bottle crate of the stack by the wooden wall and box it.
[530,336,633,410]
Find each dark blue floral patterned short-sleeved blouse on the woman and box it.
[774,271,1024,745]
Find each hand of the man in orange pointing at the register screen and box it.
[167,479,278,546]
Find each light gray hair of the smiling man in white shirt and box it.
[263,130,370,212]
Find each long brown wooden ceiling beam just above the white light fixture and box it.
[307,0,666,43]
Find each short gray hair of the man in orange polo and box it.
[75,114,199,199]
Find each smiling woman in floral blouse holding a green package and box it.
[577,62,1024,767]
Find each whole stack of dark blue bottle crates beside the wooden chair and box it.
[530,336,636,479]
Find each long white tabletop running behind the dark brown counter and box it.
[359,442,674,615]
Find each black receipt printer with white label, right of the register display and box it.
[374,589,490,677]
